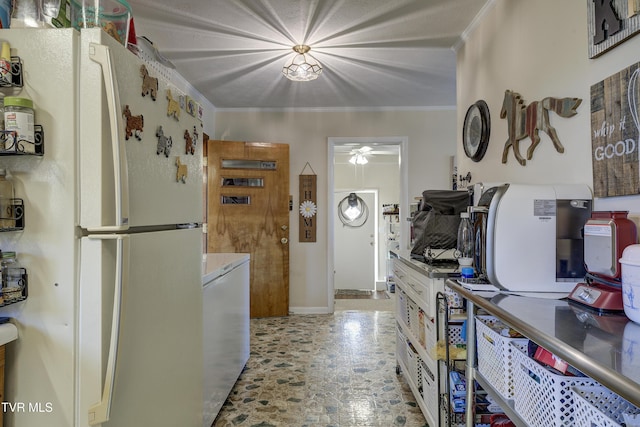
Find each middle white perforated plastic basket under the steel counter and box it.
[509,343,598,427]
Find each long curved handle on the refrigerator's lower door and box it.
[88,234,129,425]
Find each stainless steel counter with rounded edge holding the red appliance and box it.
[446,279,640,407]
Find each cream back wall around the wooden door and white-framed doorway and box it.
[213,108,456,312]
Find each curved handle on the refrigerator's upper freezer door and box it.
[88,43,129,231]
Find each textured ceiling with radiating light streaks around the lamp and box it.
[129,0,490,109]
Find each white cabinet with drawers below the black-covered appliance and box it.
[392,251,461,426]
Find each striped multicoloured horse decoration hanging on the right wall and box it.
[500,89,582,166]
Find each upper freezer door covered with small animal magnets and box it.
[78,29,203,230]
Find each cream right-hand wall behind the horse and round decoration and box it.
[456,0,640,221]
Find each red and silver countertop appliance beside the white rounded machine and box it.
[569,211,637,312]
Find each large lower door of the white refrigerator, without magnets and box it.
[77,229,203,427]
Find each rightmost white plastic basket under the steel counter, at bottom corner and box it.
[572,386,640,427]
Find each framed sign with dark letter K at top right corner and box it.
[587,0,640,58]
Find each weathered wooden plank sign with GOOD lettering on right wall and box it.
[591,63,640,197]
